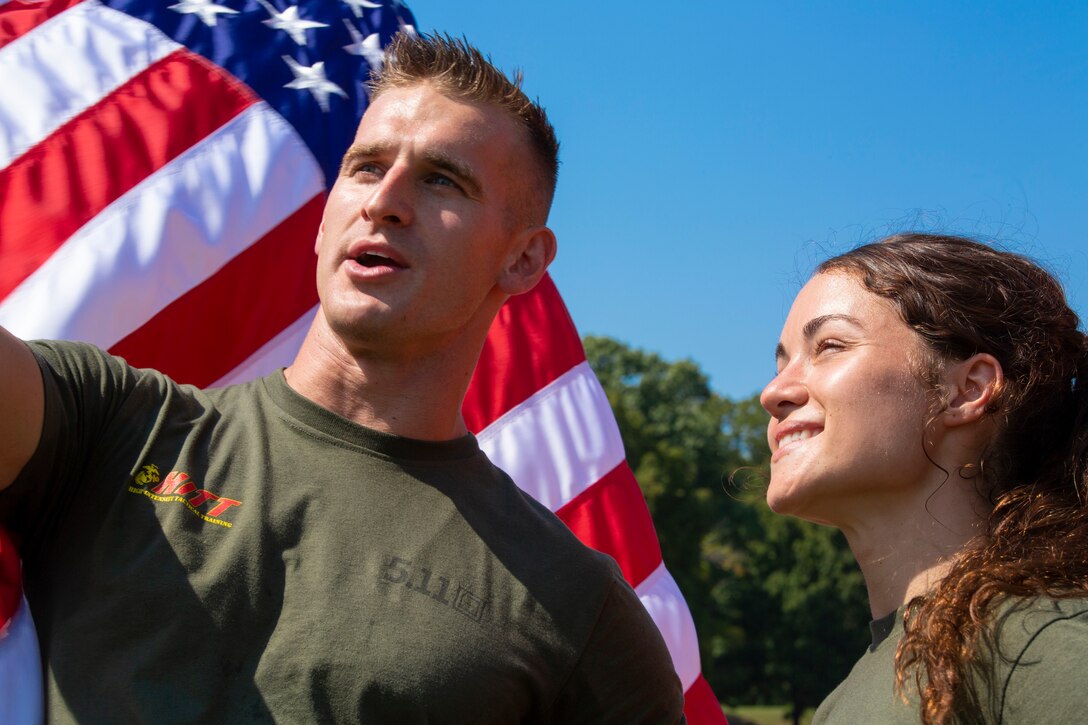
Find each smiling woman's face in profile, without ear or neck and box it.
[759,267,935,528]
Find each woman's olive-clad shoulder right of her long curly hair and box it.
[989,597,1088,723]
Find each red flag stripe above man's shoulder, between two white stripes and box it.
[556,460,662,587]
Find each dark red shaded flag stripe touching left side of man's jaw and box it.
[110,194,324,386]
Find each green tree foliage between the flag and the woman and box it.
[584,336,869,713]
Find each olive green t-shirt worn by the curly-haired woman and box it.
[813,598,1088,725]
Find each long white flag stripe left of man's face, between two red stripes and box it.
[0,102,324,347]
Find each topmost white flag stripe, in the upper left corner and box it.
[0,0,181,169]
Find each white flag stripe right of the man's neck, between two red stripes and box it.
[478,363,623,511]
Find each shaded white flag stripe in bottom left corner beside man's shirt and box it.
[0,599,44,725]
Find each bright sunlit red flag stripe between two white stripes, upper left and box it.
[0,49,255,299]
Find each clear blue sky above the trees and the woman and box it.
[407,0,1088,397]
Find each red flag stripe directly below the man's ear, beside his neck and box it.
[461,275,585,433]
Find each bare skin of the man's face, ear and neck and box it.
[286,84,555,440]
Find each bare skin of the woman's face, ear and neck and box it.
[761,272,1000,616]
